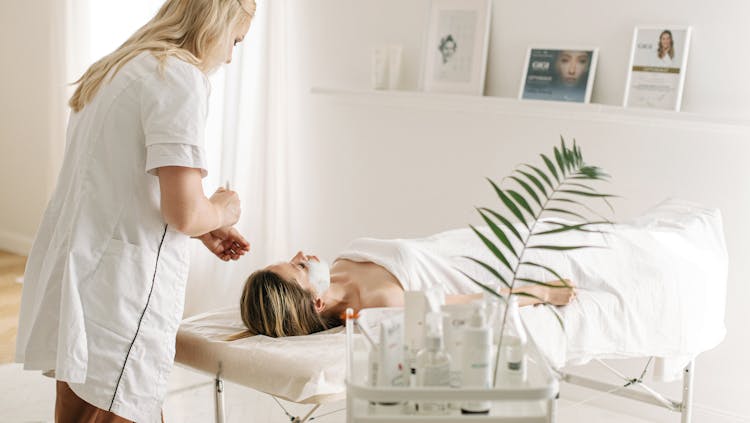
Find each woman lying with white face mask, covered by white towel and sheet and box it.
[231,200,728,376]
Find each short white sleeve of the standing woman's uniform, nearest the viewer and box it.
[141,58,208,176]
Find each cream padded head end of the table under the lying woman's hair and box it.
[175,307,346,404]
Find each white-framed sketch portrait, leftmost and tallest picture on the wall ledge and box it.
[422,0,492,95]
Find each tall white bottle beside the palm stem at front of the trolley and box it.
[461,304,492,414]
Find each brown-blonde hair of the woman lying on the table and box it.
[227,270,342,341]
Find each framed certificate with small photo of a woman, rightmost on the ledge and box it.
[623,26,691,111]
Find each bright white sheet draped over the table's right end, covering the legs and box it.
[523,200,728,379]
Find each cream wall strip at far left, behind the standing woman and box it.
[0,0,54,253]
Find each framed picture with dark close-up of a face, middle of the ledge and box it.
[518,47,599,103]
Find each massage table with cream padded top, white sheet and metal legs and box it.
[176,201,728,423]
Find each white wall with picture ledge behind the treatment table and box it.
[288,0,750,422]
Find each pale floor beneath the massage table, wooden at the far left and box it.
[0,251,647,423]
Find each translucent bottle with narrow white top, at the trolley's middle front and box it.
[417,312,451,415]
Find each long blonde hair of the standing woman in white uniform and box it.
[68,0,255,112]
